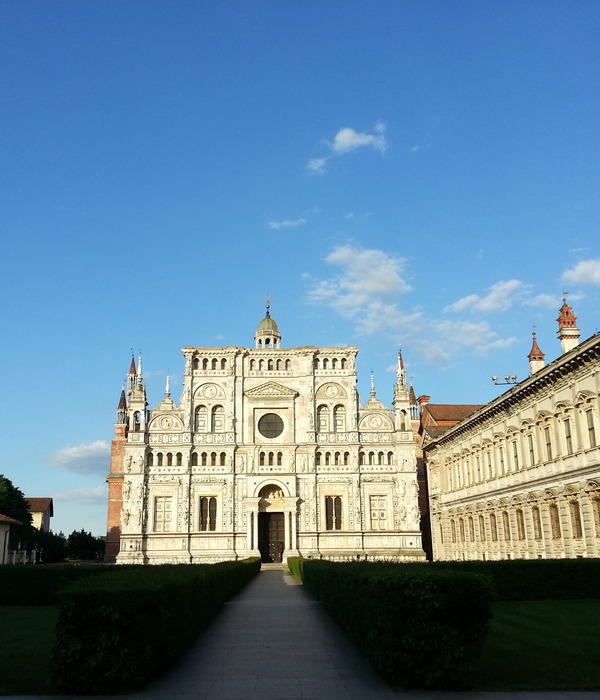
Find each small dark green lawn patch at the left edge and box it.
[0,605,58,695]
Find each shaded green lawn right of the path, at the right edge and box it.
[475,600,600,690]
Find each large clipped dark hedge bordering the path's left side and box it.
[51,558,260,694]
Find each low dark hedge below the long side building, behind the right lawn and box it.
[426,559,600,600]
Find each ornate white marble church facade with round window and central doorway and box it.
[106,307,424,564]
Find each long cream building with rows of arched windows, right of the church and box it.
[422,301,600,560]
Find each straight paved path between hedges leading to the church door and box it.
[136,568,398,700]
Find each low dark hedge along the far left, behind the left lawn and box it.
[0,564,122,605]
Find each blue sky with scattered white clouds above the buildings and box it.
[0,0,600,534]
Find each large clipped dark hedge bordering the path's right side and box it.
[288,559,492,689]
